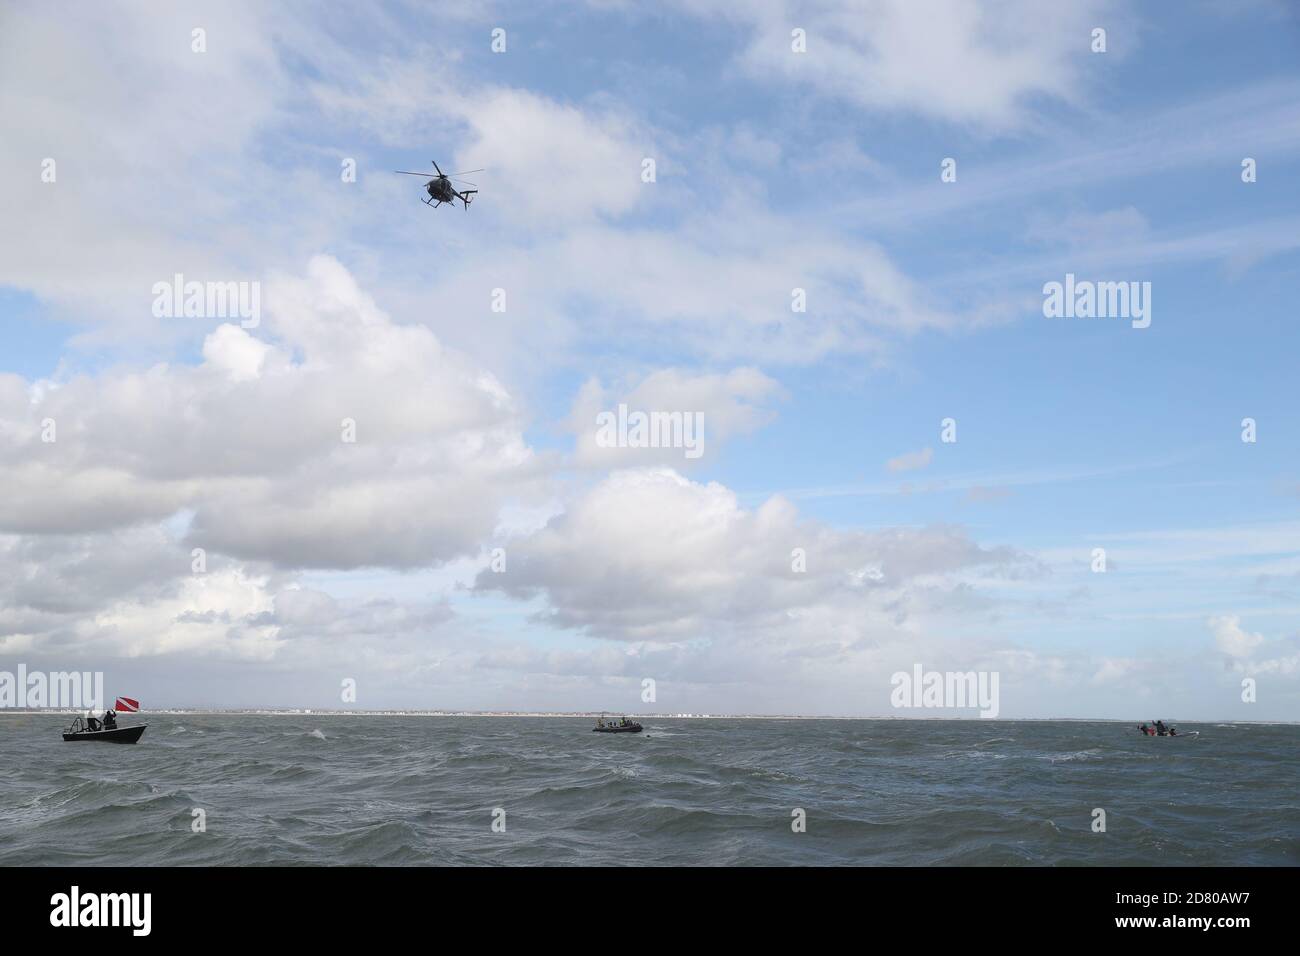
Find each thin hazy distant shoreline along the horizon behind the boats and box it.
[0,708,1300,727]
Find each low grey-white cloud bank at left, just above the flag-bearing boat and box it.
[0,525,454,666]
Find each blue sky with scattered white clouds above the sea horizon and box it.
[0,0,1300,721]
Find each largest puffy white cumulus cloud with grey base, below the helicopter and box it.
[0,256,542,568]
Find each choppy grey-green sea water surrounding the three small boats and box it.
[0,715,1300,865]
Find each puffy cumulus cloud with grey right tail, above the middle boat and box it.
[476,470,1022,643]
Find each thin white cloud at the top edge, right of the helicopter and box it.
[679,0,1135,131]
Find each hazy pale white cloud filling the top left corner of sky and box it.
[0,3,289,334]
